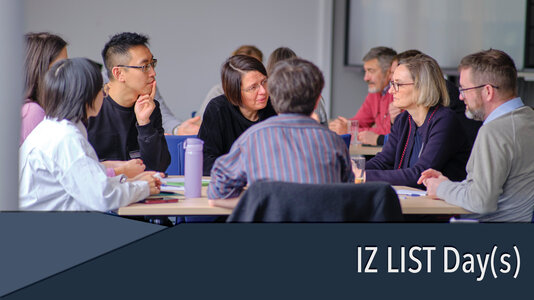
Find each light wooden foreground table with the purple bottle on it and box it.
[118,180,470,216]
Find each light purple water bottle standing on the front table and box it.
[184,138,204,198]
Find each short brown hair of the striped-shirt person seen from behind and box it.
[267,58,324,116]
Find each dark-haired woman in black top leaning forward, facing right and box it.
[198,55,276,176]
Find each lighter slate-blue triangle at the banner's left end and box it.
[0,212,167,297]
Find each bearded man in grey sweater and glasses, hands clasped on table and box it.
[418,49,534,222]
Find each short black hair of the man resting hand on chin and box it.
[102,32,148,80]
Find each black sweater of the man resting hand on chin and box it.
[87,96,171,172]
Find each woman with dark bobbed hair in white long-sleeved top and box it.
[19,58,161,211]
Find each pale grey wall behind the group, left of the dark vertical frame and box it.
[24,0,333,119]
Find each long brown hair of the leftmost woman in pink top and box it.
[24,32,67,106]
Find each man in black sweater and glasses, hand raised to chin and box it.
[87,32,171,172]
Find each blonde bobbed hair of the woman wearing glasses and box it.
[399,54,450,107]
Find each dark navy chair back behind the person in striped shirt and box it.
[227,181,403,222]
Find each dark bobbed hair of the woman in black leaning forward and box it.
[221,55,267,106]
